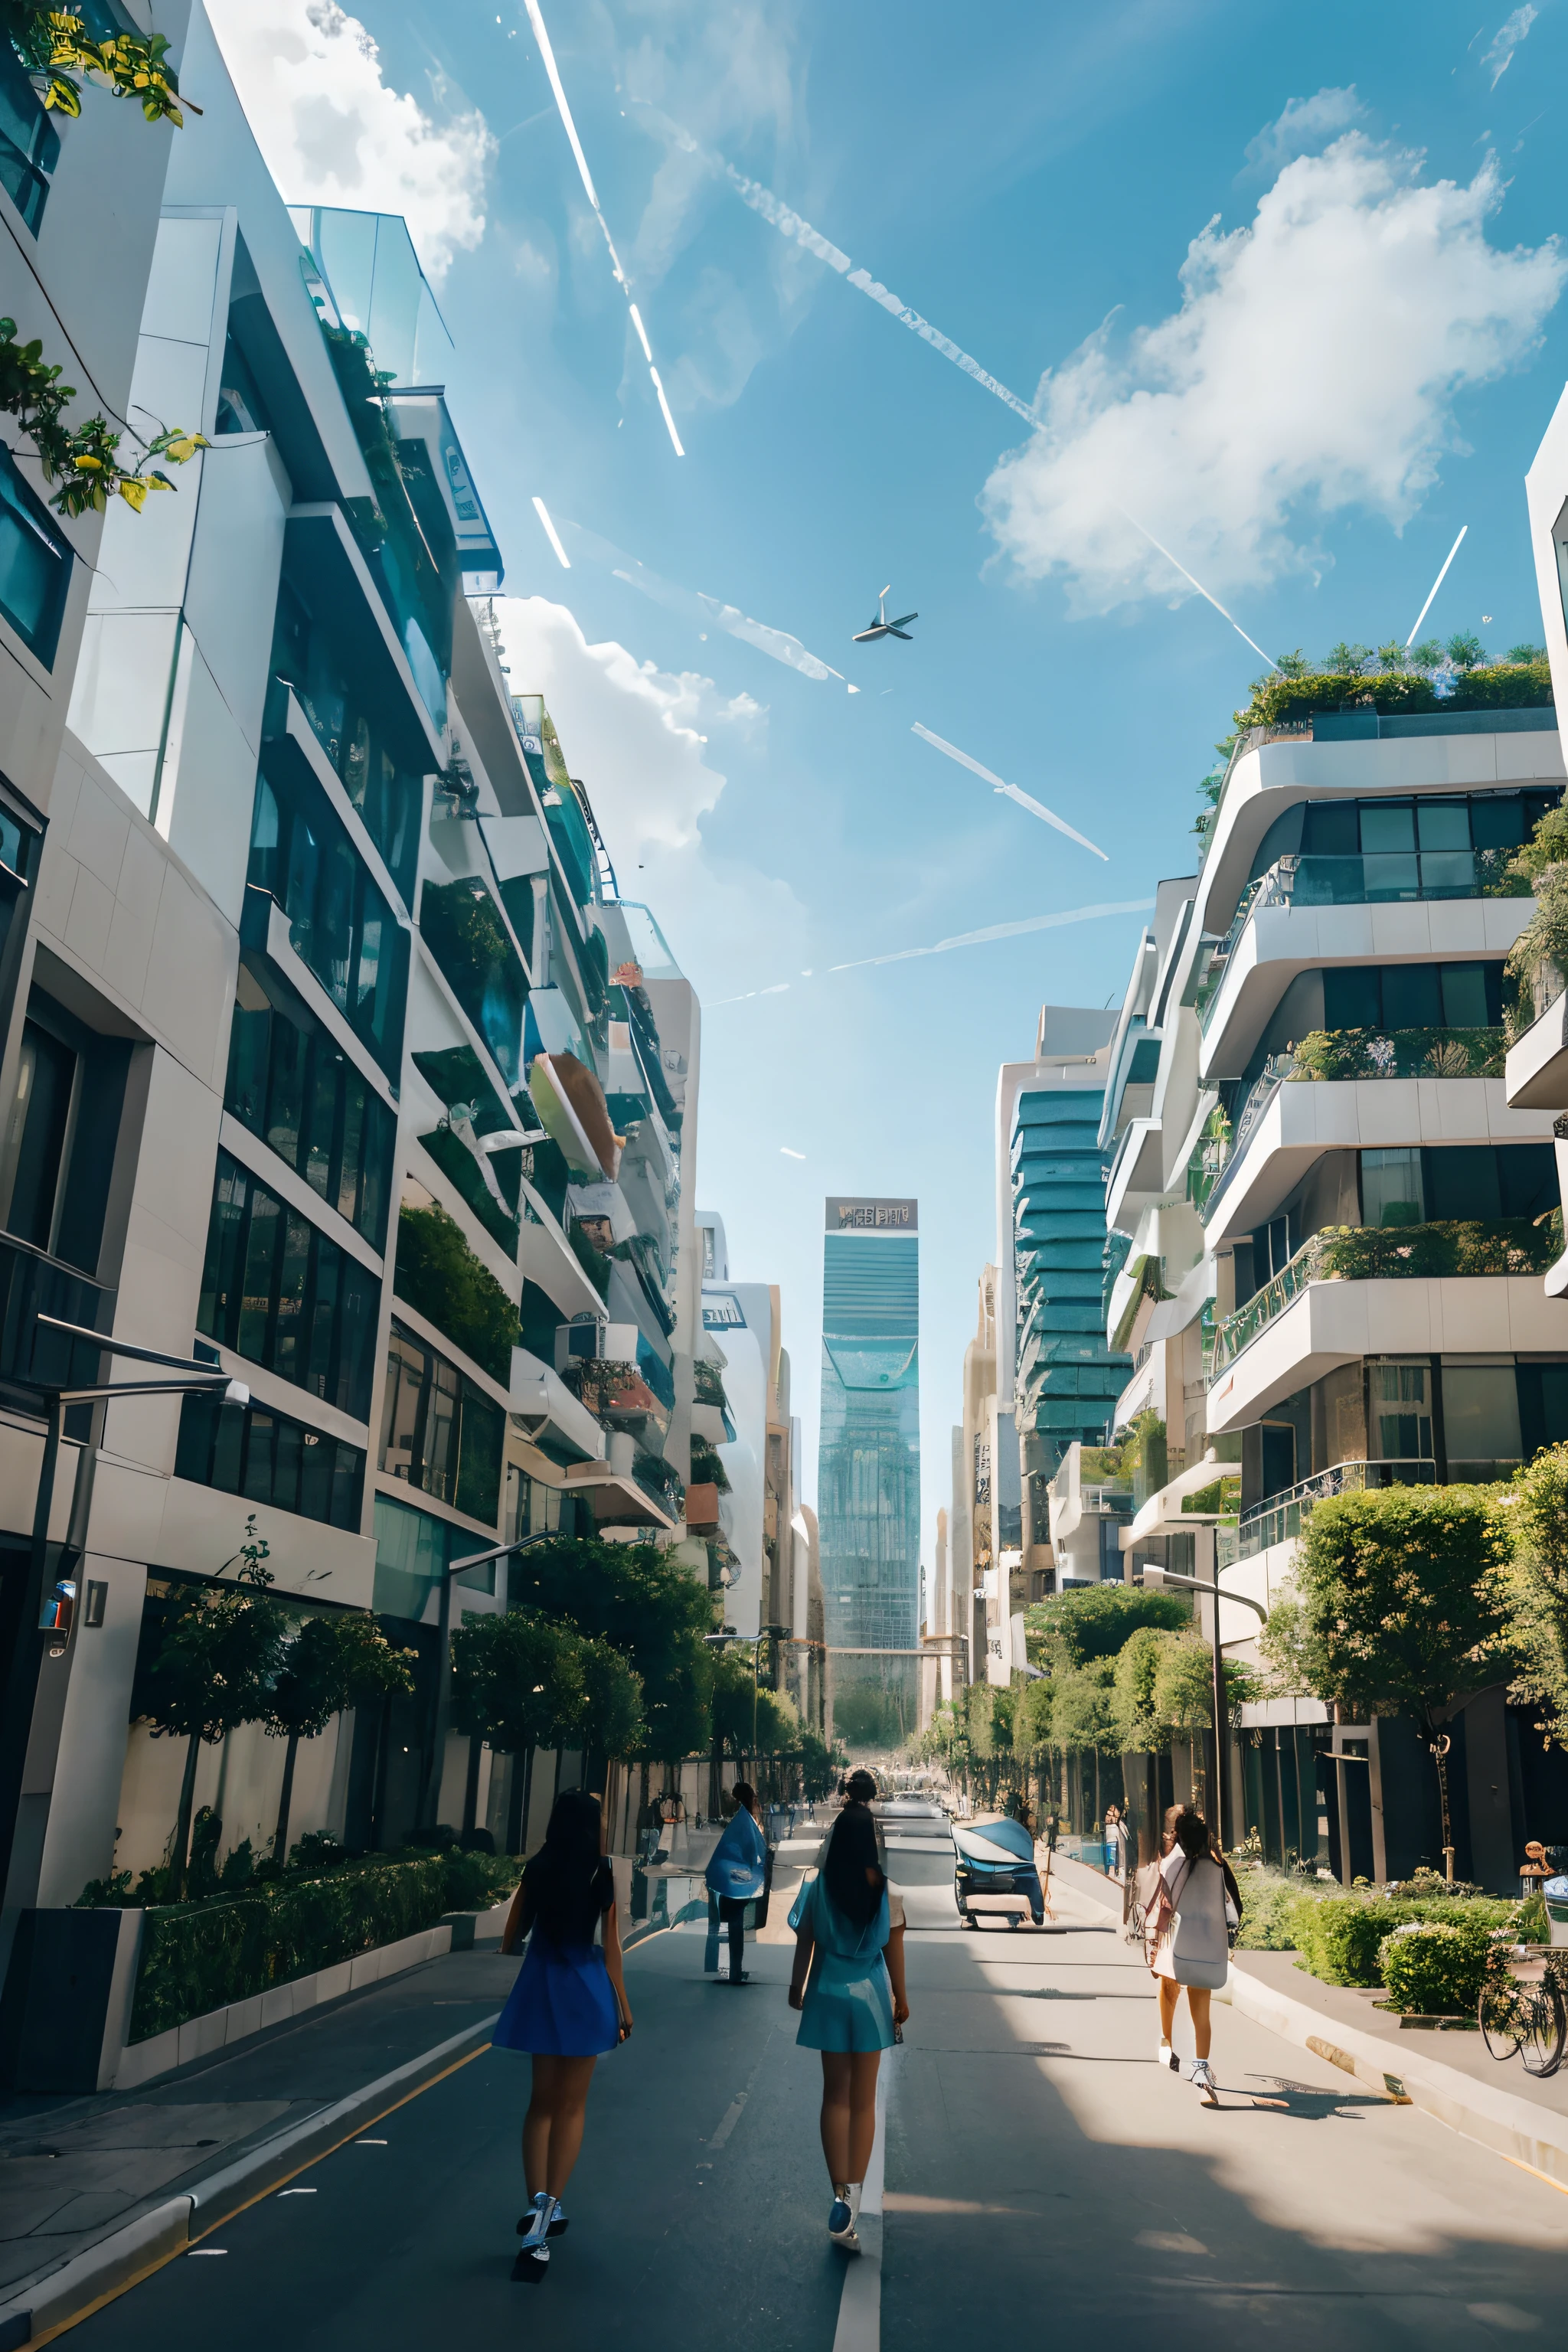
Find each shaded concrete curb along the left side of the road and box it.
[0,2011,501,2352]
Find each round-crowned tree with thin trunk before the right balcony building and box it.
[1263,1487,1509,1874]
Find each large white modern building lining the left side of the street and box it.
[0,7,701,1959]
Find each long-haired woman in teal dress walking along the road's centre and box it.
[790,1773,910,2253]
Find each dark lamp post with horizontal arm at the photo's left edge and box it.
[0,1315,249,1891]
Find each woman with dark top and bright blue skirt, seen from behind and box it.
[492,1788,632,2286]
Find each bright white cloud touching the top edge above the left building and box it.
[207,0,496,277]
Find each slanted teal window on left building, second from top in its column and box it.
[249,750,409,1070]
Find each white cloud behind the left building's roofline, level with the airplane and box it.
[496,595,811,998]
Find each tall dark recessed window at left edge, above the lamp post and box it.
[0,985,132,1275]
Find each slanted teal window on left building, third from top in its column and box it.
[224,952,397,1249]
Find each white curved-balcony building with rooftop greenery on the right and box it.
[1105,682,1568,1884]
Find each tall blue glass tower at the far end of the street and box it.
[818,1200,920,1745]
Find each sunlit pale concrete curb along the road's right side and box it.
[1063,1863,1568,2190]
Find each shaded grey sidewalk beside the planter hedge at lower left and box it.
[0,1942,518,2345]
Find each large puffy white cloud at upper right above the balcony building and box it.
[982,132,1568,614]
